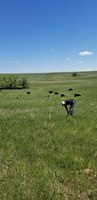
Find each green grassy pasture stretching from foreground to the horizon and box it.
[0,72,97,200]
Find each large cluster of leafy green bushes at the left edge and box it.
[0,75,29,89]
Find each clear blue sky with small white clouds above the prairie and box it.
[0,0,97,73]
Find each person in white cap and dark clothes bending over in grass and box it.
[61,99,76,115]
